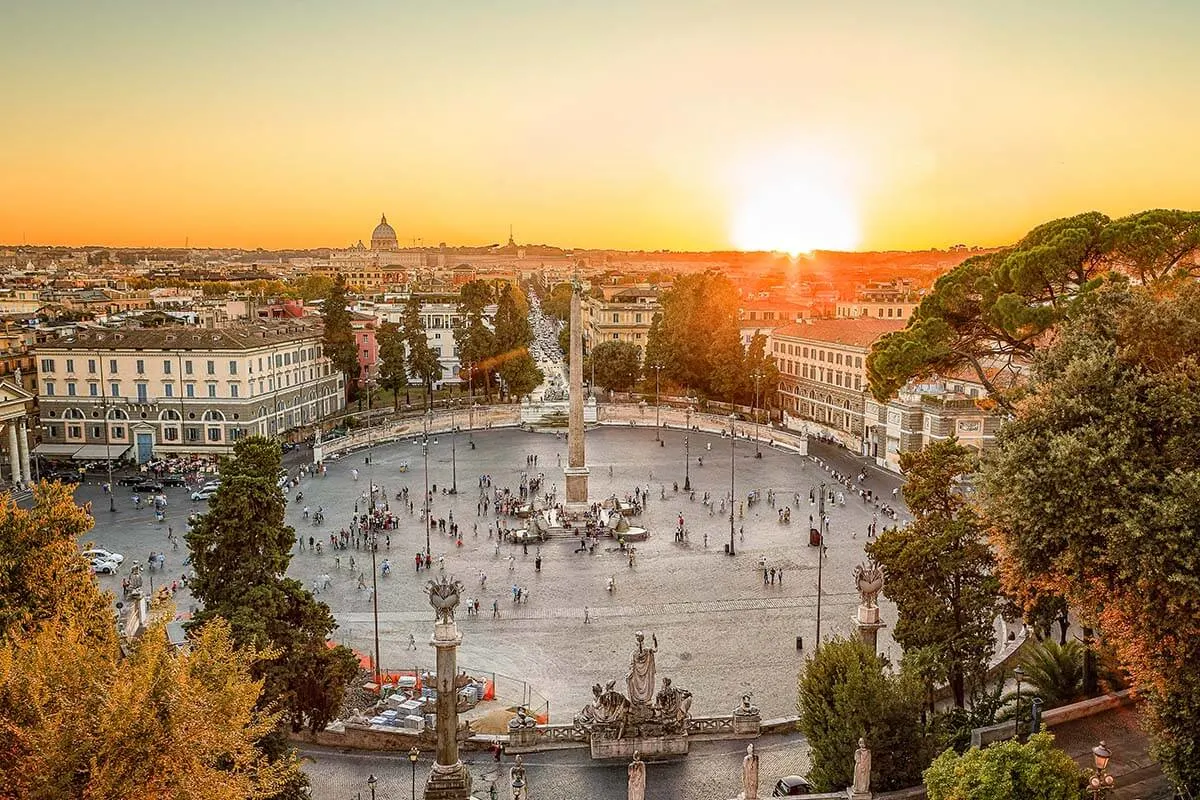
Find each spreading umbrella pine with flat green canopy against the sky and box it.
[866,210,1200,411]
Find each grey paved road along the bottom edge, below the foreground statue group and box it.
[301,734,810,800]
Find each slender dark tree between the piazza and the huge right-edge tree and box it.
[866,439,1000,709]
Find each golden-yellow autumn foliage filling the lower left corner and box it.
[0,483,304,800]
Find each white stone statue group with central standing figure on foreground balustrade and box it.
[575,631,691,752]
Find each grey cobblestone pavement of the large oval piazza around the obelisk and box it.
[77,427,898,722]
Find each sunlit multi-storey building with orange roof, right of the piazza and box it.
[769,319,904,452]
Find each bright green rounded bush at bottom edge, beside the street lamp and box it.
[924,733,1084,800]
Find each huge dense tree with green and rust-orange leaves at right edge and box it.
[980,279,1200,786]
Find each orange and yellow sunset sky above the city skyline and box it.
[0,0,1200,249]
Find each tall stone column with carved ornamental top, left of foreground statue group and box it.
[424,575,470,800]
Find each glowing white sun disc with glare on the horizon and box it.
[731,148,860,255]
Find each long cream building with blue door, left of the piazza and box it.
[36,321,344,463]
